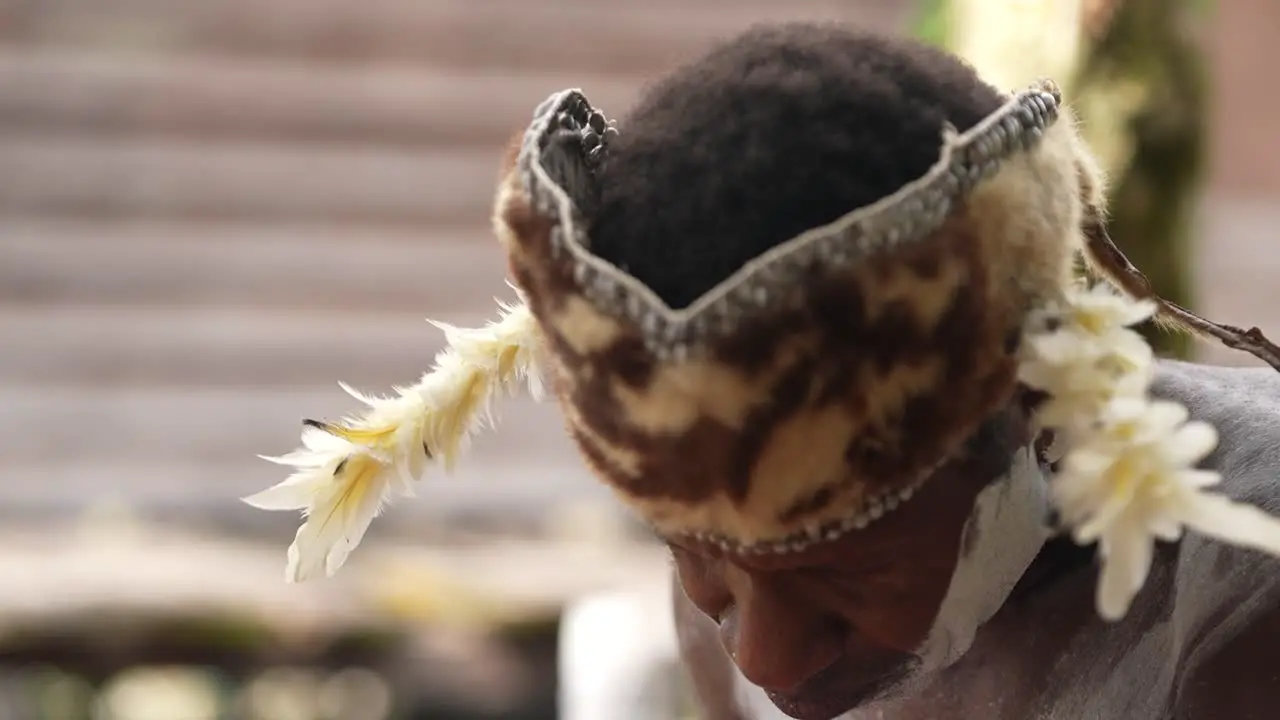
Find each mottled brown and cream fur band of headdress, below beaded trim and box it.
[494,26,1100,548]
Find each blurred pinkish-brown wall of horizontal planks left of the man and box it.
[0,0,901,524]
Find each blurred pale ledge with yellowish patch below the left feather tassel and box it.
[0,518,669,630]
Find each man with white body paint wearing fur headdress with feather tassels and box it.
[250,24,1280,720]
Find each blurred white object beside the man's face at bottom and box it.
[559,573,684,720]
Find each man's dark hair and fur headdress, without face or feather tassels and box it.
[495,26,1083,543]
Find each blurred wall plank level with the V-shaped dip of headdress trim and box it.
[0,305,497,388]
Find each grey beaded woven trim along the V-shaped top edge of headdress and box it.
[517,81,1061,360]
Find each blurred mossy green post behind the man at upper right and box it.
[914,0,1208,357]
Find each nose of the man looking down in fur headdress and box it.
[719,578,846,692]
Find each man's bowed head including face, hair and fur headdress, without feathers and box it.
[497,24,1084,719]
